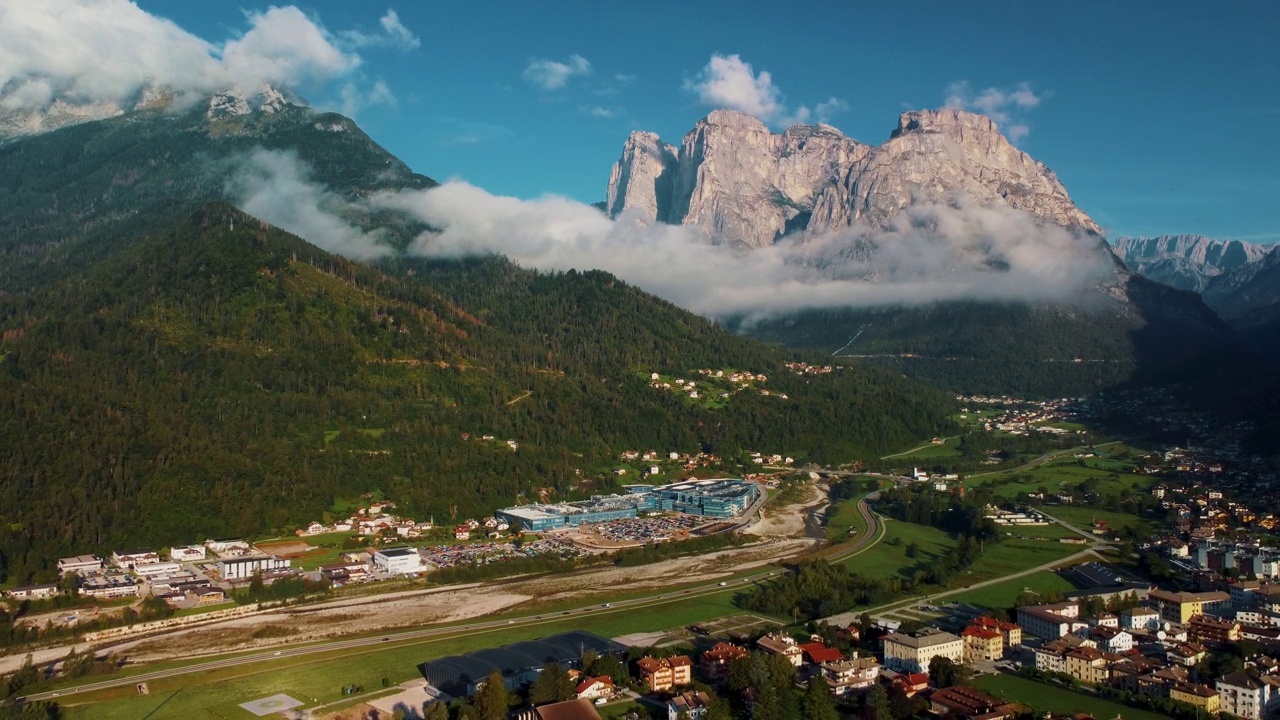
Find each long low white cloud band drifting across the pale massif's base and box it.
[229,151,1114,319]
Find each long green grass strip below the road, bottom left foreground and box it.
[64,591,739,720]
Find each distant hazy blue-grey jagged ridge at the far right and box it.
[1111,234,1270,292]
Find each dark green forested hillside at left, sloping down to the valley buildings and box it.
[0,204,952,580]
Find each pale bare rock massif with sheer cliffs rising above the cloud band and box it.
[607,109,1101,247]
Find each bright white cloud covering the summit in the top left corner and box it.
[0,0,419,110]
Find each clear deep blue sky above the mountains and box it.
[45,0,1280,242]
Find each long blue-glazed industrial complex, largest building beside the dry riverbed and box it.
[494,479,760,533]
